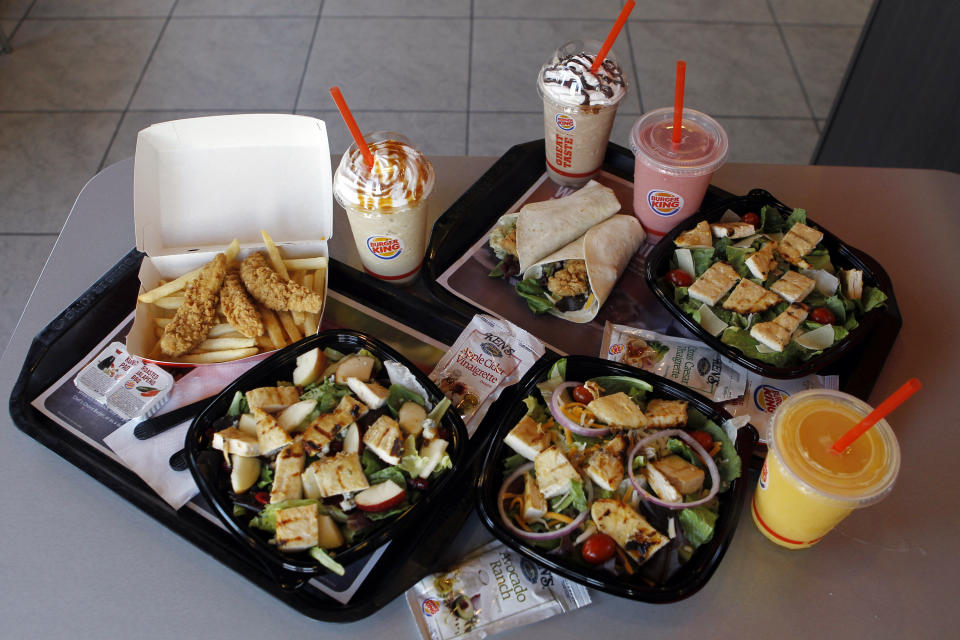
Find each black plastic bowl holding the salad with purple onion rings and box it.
[477,355,757,603]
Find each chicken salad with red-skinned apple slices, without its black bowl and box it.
[211,348,452,575]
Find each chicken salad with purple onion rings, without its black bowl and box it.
[497,360,741,578]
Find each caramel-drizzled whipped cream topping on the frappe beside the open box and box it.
[333,132,435,213]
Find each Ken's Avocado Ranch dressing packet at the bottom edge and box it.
[407,541,591,640]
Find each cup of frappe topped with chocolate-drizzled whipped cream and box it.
[537,40,627,186]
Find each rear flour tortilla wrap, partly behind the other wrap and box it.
[491,180,620,273]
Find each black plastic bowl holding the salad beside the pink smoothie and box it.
[644,189,901,379]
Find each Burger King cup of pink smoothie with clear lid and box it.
[630,107,728,242]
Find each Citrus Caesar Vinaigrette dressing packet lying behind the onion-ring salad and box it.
[600,322,747,402]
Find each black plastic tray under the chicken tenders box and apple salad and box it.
[9,250,485,622]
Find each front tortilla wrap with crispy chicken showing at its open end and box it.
[515,215,645,322]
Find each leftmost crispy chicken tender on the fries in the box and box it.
[160,253,227,356]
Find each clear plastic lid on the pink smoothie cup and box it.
[630,107,728,176]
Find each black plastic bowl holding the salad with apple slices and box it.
[185,330,468,590]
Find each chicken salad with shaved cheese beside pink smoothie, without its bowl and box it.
[660,206,887,367]
